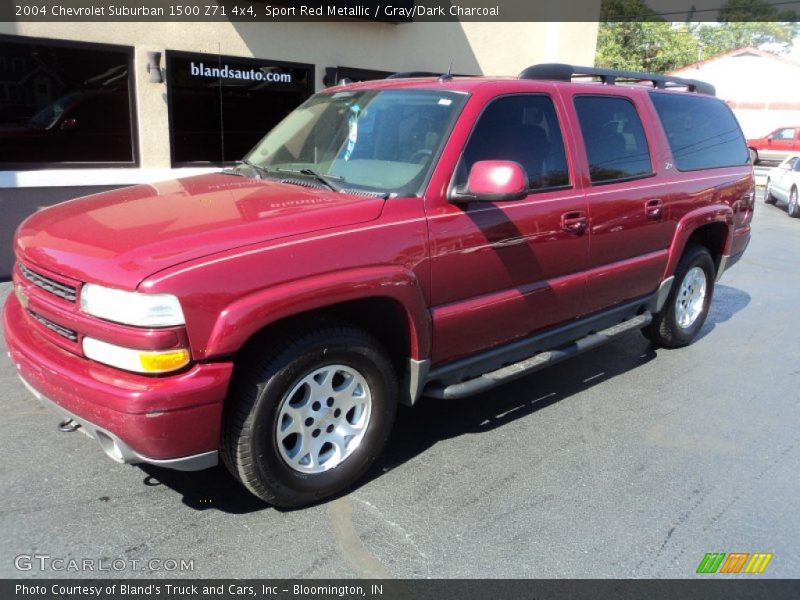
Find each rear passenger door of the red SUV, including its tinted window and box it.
[570,88,675,314]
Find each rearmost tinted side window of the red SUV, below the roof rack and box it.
[650,92,748,171]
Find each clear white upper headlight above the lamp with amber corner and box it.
[81,283,186,327]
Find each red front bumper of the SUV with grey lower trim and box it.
[3,294,233,470]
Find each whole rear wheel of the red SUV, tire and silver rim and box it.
[642,245,716,348]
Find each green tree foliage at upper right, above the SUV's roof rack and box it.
[595,0,798,73]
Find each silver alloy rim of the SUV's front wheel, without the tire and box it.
[275,365,372,474]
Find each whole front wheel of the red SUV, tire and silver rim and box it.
[222,325,398,508]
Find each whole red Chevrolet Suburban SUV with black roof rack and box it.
[4,65,754,506]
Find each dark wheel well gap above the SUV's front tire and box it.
[237,297,411,377]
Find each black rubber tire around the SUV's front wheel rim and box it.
[221,324,398,508]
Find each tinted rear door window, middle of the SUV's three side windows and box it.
[575,96,653,184]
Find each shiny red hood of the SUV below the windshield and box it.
[15,173,385,289]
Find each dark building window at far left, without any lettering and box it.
[0,36,136,169]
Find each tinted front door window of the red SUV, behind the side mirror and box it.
[456,94,569,191]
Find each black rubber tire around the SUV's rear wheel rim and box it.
[642,245,716,348]
